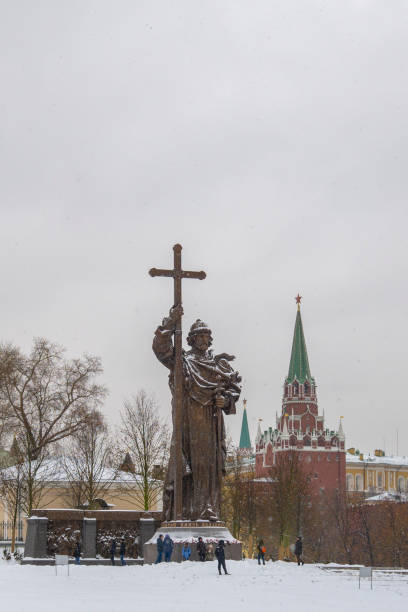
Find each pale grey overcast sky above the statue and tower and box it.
[0,0,408,455]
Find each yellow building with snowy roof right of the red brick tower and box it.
[346,448,408,495]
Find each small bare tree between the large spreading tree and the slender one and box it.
[62,410,118,508]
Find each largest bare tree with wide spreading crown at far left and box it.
[0,338,106,514]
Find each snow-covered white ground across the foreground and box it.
[0,561,408,612]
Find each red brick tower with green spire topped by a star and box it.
[255,295,346,494]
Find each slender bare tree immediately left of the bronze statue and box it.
[120,390,170,510]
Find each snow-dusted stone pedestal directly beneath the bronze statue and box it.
[143,521,242,564]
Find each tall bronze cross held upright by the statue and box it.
[149,244,206,521]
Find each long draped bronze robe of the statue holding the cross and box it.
[153,319,240,520]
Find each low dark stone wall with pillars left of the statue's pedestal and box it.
[24,509,162,559]
